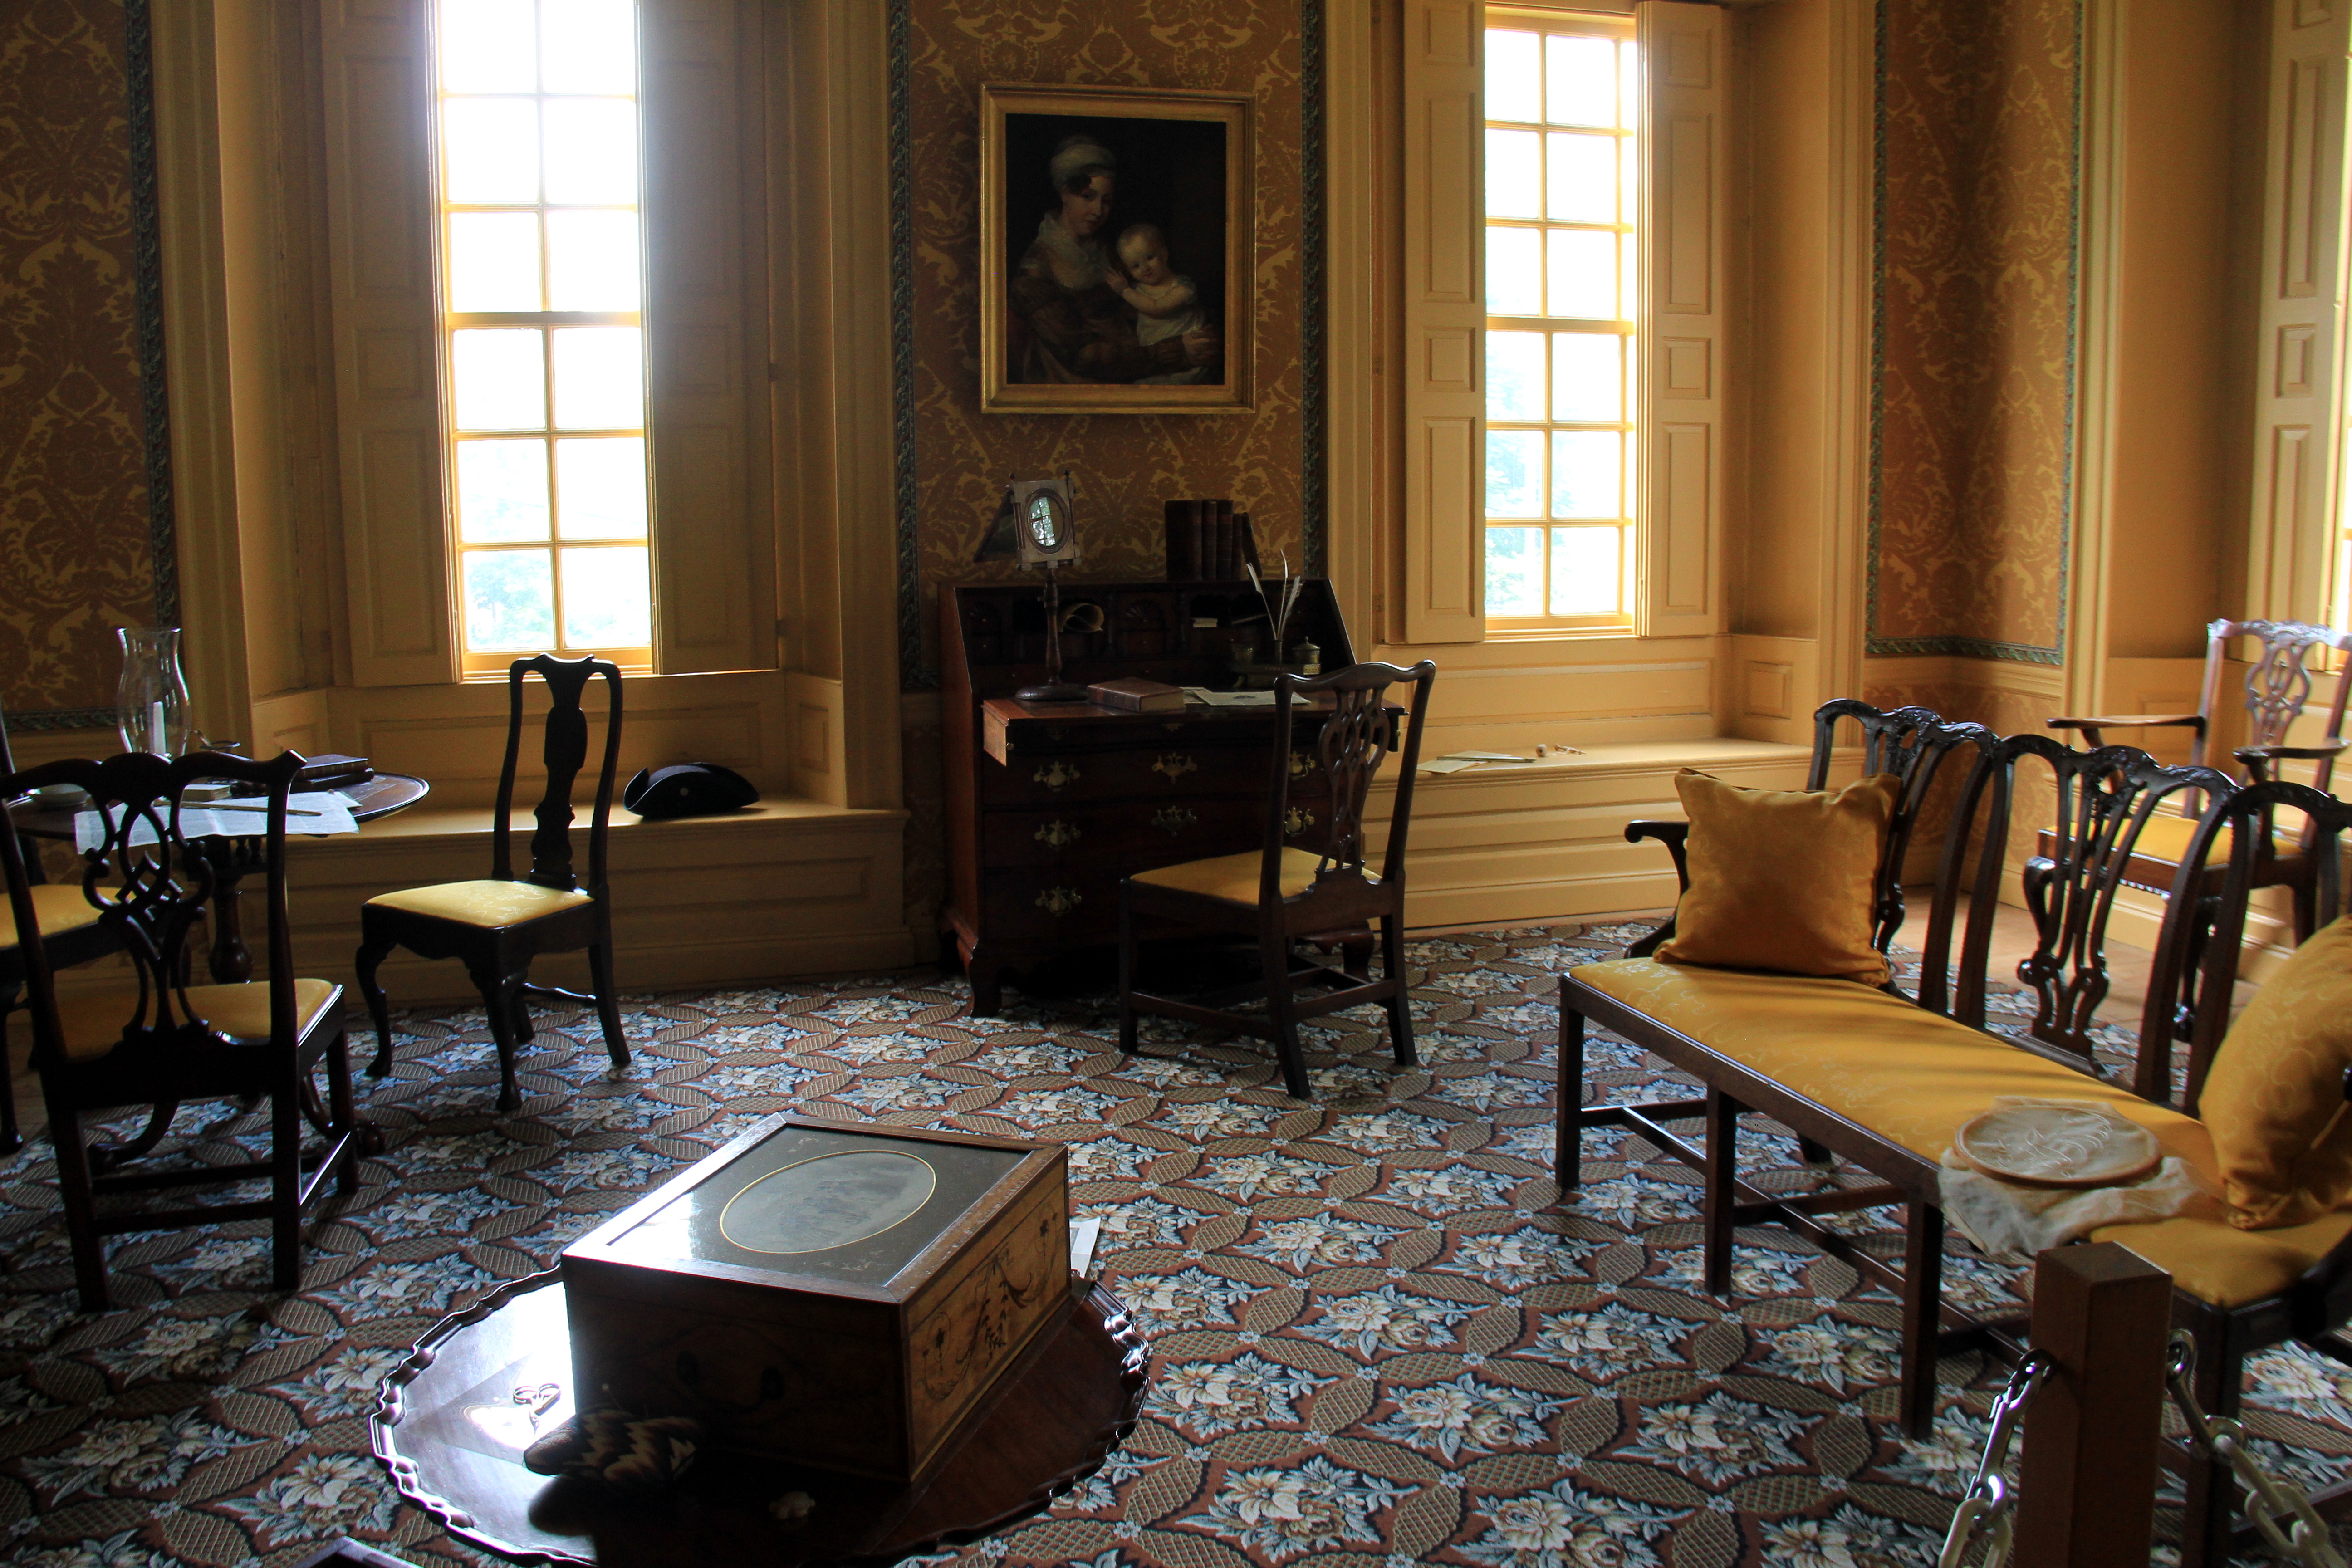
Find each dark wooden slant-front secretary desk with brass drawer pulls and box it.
[938,578,1355,1015]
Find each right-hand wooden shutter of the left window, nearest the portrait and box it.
[640,0,776,675]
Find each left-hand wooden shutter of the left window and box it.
[320,0,456,686]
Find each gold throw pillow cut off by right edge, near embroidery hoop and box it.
[2197,915,2352,1230]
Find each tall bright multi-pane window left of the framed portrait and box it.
[435,0,654,672]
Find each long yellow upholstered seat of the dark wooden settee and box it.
[1569,959,2352,1307]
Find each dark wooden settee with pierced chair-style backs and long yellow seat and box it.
[1559,710,2352,1563]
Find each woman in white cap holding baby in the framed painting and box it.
[1004,134,1225,383]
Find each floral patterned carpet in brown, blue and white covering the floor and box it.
[0,926,2352,1568]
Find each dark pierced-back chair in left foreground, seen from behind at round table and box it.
[0,752,367,1312]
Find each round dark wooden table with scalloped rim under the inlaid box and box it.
[369,1269,1148,1568]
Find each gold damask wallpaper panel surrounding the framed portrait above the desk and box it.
[903,0,1305,686]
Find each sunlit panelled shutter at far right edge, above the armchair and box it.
[2241,0,2352,621]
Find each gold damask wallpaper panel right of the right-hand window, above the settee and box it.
[1870,0,2082,663]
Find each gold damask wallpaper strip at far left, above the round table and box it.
[0,0,155,722]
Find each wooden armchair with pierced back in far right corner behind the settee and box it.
[2042,621,2352,943]
